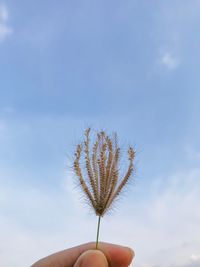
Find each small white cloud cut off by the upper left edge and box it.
[0,5,12,42]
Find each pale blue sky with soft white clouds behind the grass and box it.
[0,0,200,267]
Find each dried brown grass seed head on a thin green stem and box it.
[73,128,135,249]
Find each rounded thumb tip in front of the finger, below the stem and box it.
[74,250,108,267]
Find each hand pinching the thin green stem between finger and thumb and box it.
[31,242,134,267]
